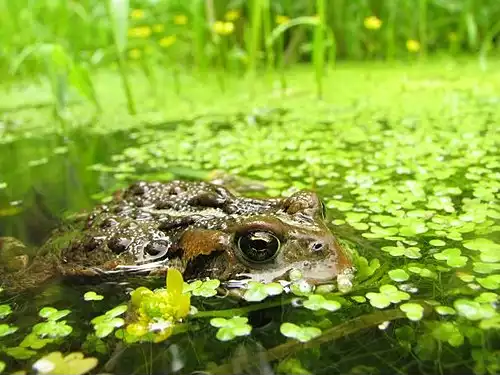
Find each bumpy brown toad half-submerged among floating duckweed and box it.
[0,181,352,287]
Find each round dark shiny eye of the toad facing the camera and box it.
[238,231,281,263]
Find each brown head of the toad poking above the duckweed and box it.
[180,191,352,290]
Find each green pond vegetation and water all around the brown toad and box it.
[0,0,500,375]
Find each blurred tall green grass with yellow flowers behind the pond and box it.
[0,0,500,114]
